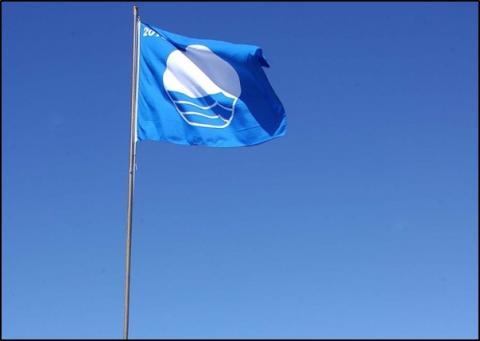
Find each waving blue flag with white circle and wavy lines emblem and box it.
[137,23,287,147]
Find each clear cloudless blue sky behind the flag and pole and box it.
[2,2,478,338]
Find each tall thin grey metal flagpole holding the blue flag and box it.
[123,6,140,339]
